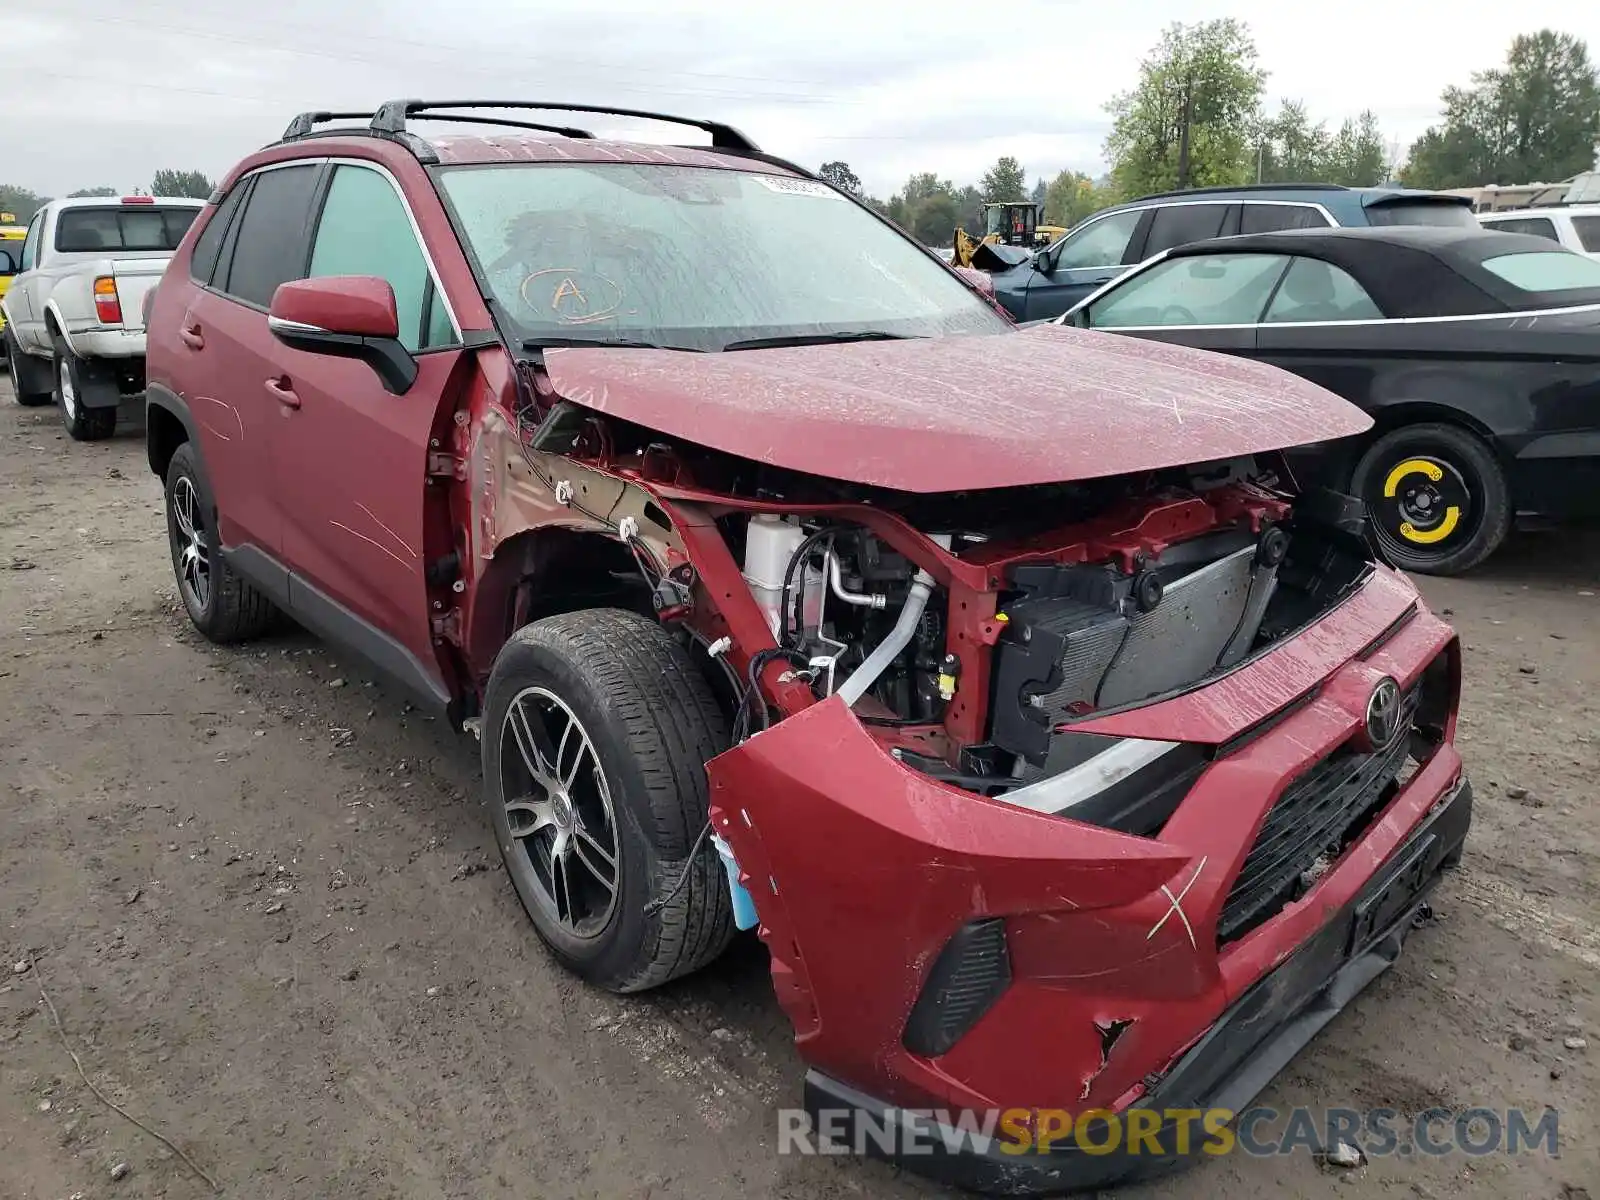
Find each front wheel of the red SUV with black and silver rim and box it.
[483,610,734,992]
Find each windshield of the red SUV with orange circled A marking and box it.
[438,163,1010,350]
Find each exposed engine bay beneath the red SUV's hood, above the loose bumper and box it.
[502,382,1371,834]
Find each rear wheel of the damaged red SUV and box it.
[166,442,277,643]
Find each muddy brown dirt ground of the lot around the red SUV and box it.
[0,376,1600,1200]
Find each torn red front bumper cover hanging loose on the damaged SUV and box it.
[709,573,1470,1190]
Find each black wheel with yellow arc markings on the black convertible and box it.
[1350,422,1512,574]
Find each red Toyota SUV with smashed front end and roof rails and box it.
[149,101,1472,1194]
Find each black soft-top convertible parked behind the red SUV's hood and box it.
[1061,227,1600,574]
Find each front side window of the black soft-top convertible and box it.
[1088,254,1288,330]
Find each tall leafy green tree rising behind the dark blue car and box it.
[1106,18,1267,197]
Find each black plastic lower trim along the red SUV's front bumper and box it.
[805,778,1472,1195]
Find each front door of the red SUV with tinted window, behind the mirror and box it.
[265,162,466,694]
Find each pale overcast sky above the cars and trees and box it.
[0,0,1600,197]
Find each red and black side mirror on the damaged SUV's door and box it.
[267,275,416,395]
